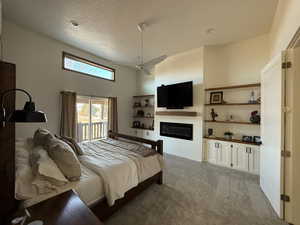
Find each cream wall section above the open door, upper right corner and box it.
[270,0,300,57]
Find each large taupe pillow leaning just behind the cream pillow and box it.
[45,135,81,181]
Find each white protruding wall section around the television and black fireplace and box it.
[137,48,203,161]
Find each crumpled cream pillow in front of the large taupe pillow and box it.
[29,146,68,186]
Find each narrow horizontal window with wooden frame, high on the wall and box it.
[63,52,115,81]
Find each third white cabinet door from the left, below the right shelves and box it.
[232,144,249,172]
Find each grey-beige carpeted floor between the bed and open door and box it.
[105,155,285,225]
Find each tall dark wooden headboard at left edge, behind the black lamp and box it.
[0,61,17,224]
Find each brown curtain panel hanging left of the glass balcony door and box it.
[60,91,77,140]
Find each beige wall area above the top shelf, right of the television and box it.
[204,35,269,88]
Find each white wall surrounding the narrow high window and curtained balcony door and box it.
[3,22,136,137]
